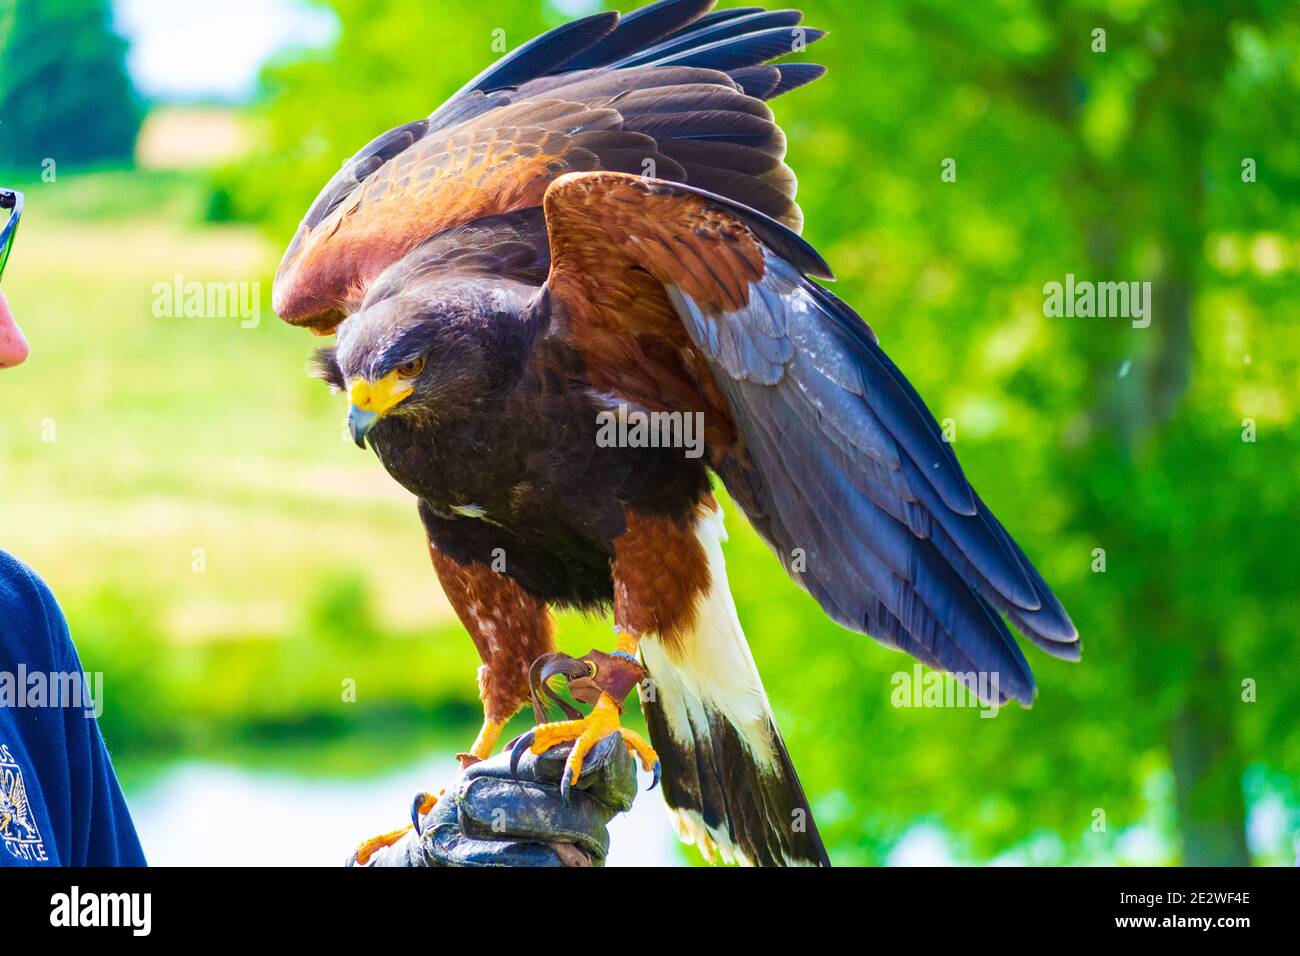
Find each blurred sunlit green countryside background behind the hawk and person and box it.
[0,0,1300,865]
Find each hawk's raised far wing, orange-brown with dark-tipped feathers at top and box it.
[273,0,823,334]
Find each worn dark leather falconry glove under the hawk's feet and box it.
[347,734,637,866]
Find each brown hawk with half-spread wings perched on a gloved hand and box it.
[274,0,1079,865]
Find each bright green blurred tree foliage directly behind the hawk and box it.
[234,0,1300,864]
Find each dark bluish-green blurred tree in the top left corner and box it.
[0,0,143,168]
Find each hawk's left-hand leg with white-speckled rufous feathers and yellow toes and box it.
[356,544,554,865]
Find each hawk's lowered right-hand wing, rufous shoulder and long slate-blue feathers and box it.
[545,173,1079,704]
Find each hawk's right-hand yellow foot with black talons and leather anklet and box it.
[511,631,660,799]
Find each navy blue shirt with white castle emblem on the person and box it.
[0,551,144,866]
